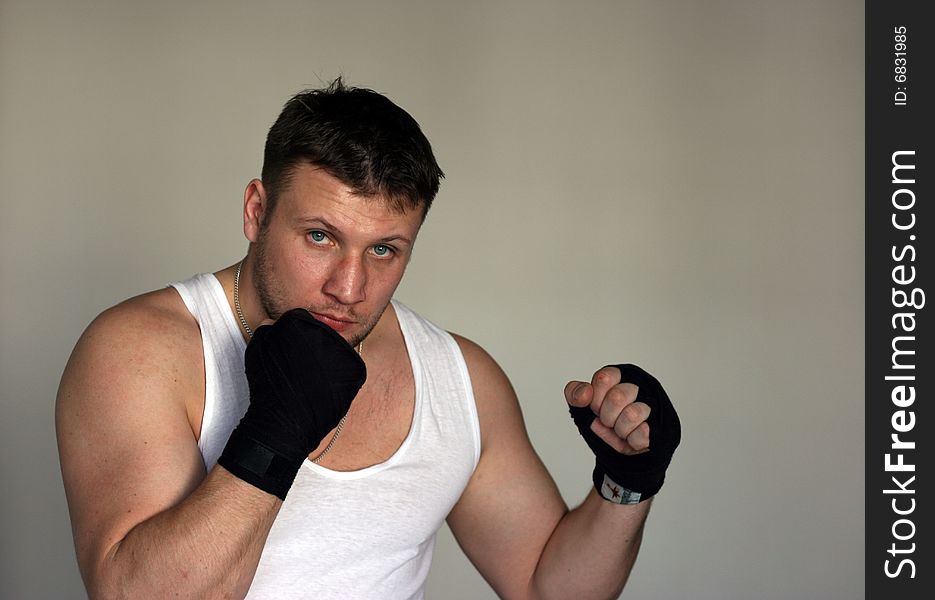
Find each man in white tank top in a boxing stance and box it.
[56,80,679,598]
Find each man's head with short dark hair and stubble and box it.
[244,80,443,344]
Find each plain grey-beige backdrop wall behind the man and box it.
[0,0,864,600]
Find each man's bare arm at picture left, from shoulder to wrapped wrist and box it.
[56,290,281,598]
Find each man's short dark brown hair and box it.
[262,77,445,218]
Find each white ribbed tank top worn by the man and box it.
[166,274,480,600]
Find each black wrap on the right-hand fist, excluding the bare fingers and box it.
[569,364,682,504]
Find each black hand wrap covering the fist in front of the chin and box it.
[218,308,367,500]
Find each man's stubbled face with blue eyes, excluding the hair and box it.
[253,165,422,346]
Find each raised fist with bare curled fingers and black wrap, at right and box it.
[565,364,682,504]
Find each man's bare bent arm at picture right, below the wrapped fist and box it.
[448,338,649,600]
